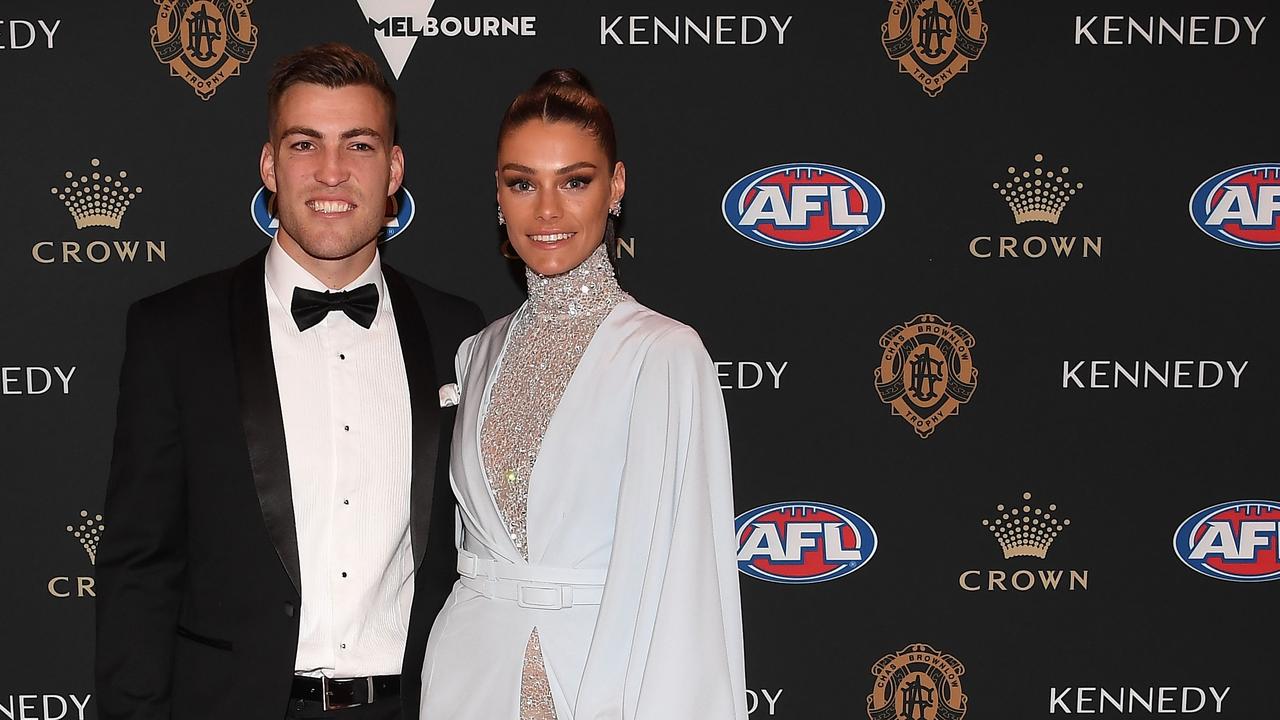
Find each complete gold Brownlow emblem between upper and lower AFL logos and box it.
[876,314,978,438]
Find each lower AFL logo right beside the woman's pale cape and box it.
[735,501,877,584]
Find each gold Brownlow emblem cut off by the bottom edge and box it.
[867,643,969,720]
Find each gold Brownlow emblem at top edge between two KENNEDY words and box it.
[881,0,987,97]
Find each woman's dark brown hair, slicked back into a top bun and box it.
[498,68,618,263]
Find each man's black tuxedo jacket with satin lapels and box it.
[96,251,483,720]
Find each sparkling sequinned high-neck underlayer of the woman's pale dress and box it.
[480,245,627,720]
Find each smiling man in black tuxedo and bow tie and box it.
[96,45,483,720]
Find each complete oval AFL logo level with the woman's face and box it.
[722,163,884,250]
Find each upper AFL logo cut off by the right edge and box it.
[1190,163,1280,250]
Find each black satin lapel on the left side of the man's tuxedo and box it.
[230,251,302,594]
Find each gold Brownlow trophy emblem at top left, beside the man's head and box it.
[151,0,257,100]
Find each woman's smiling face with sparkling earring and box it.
[497,120,626,275]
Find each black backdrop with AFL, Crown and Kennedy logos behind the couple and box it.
[0,0,1280,720]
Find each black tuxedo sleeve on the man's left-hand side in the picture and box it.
[95,302,187,720]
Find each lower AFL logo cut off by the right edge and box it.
[1174,500,1280,583]
